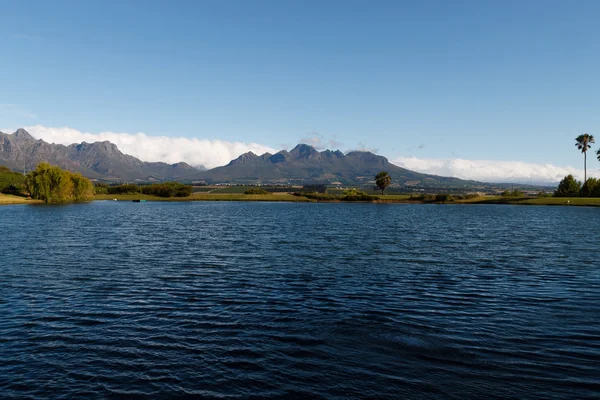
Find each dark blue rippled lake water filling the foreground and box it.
[0,202,600,399]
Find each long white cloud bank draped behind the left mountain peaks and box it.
[25,125,276,168]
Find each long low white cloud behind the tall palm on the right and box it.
[392,157,600,184]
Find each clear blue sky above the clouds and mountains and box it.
[0,0,600,167]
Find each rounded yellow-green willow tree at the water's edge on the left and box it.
[25,163,94,203]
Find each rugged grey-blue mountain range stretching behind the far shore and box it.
[0,129,483,188]
